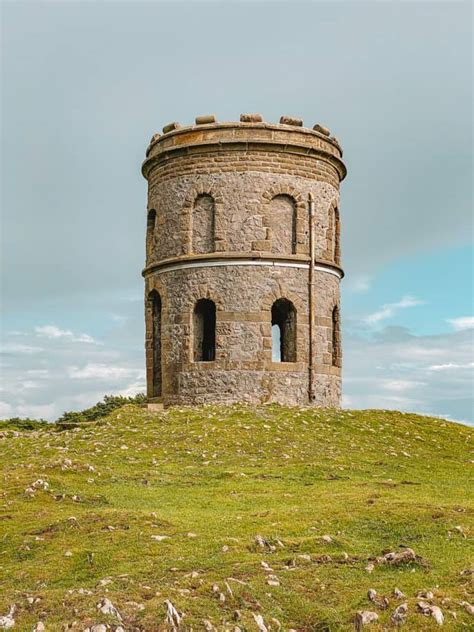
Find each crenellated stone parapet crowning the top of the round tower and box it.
[142,114,346,180]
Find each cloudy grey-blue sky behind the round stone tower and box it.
[0,0,474,423]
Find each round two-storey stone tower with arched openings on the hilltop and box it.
[142,114,346,406]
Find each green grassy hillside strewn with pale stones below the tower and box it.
[0,405,473,632]
